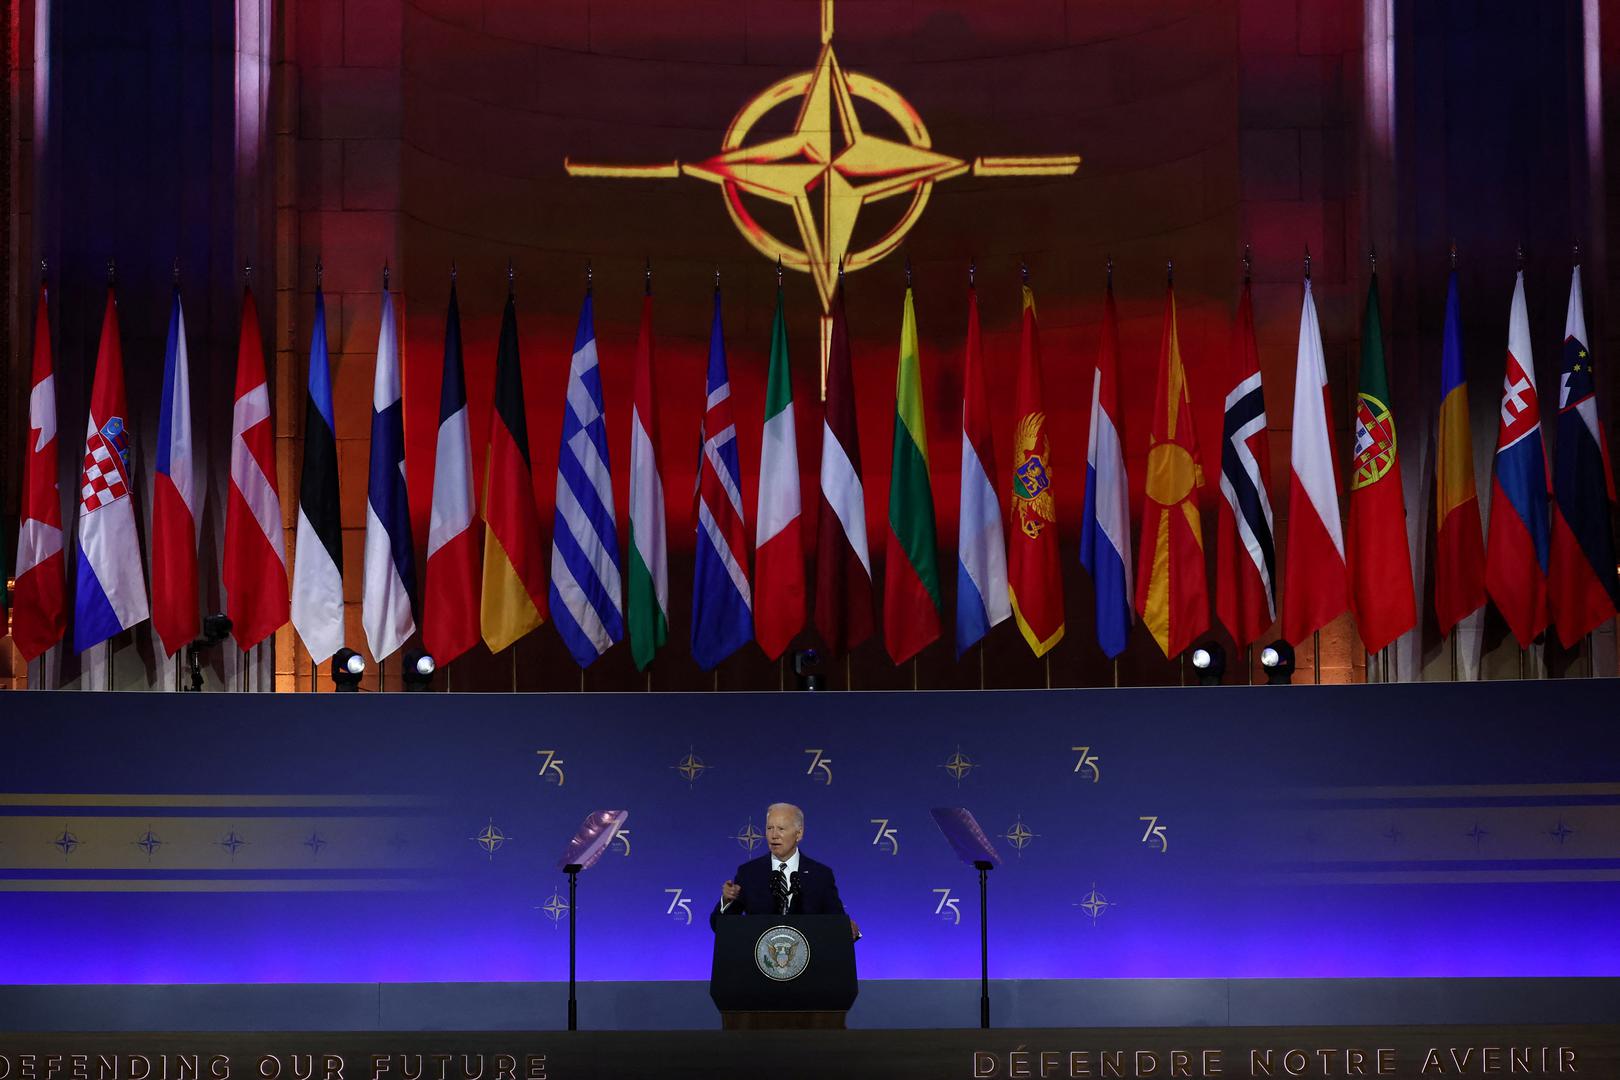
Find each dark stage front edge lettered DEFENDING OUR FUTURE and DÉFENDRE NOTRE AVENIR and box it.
[0,1025,1620,1080]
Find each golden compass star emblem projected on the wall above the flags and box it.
[564,0,1081,317]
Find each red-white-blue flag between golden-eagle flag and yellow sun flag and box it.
[1081,282,1136,659]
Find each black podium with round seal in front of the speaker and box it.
[710,915,860,1031]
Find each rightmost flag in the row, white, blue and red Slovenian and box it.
[1547,266,1620,648]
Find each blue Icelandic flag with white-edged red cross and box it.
[692,288,753,670]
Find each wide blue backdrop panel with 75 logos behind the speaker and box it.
[0,680,1620,983]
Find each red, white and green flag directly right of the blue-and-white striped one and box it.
[629,291,667,670]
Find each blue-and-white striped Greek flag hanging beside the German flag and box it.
[548,290,624,667]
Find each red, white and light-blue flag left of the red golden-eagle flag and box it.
[956,288,1013,659]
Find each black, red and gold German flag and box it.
[478,293,549,653]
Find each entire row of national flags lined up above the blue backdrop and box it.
[13,259,1620,670]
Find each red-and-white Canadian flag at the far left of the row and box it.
[11,283,68,661]
